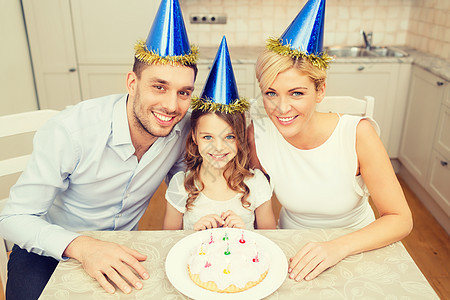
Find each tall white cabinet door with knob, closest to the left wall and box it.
[22,0,81,110]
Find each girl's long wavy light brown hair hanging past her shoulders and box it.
[184,110,253,210]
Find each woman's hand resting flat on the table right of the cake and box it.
[288,241,347,281]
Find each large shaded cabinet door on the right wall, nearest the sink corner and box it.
[399,67,444,186]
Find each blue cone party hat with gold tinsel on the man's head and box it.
[135,0,198,65]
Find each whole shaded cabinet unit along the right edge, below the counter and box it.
[399,66,450,223]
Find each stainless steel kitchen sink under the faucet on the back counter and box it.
[325,46,408,57]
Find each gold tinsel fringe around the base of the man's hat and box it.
[134,40,198,66]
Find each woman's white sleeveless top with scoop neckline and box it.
[252,109,379,228]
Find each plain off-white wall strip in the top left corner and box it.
[0,0,37,115]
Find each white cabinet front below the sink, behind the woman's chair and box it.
[326,63,399,158]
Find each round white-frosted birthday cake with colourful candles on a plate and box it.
[187,229,269,293]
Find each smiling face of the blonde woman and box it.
[263,68,325,140]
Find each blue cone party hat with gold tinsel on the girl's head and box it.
[191,36,249,113]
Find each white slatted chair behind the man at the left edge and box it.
[0,109,58,291]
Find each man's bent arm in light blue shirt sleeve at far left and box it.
[0,121,78,259]
